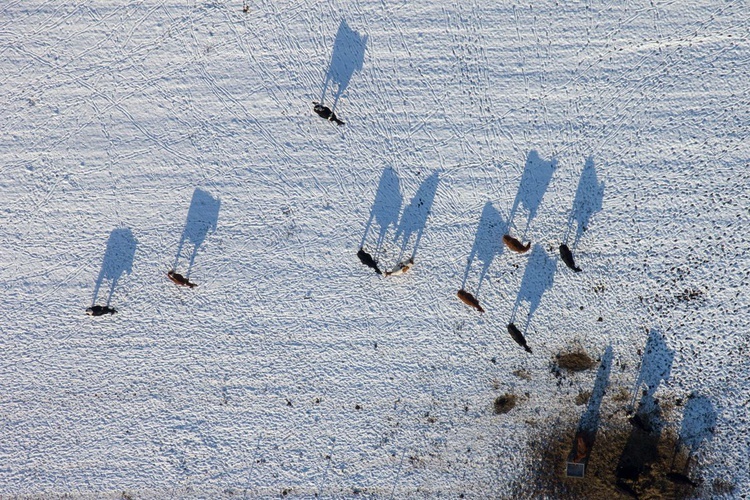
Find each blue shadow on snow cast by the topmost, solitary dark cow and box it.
[320,20,367,110]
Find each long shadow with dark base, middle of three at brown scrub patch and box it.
[615,329,674,483]
